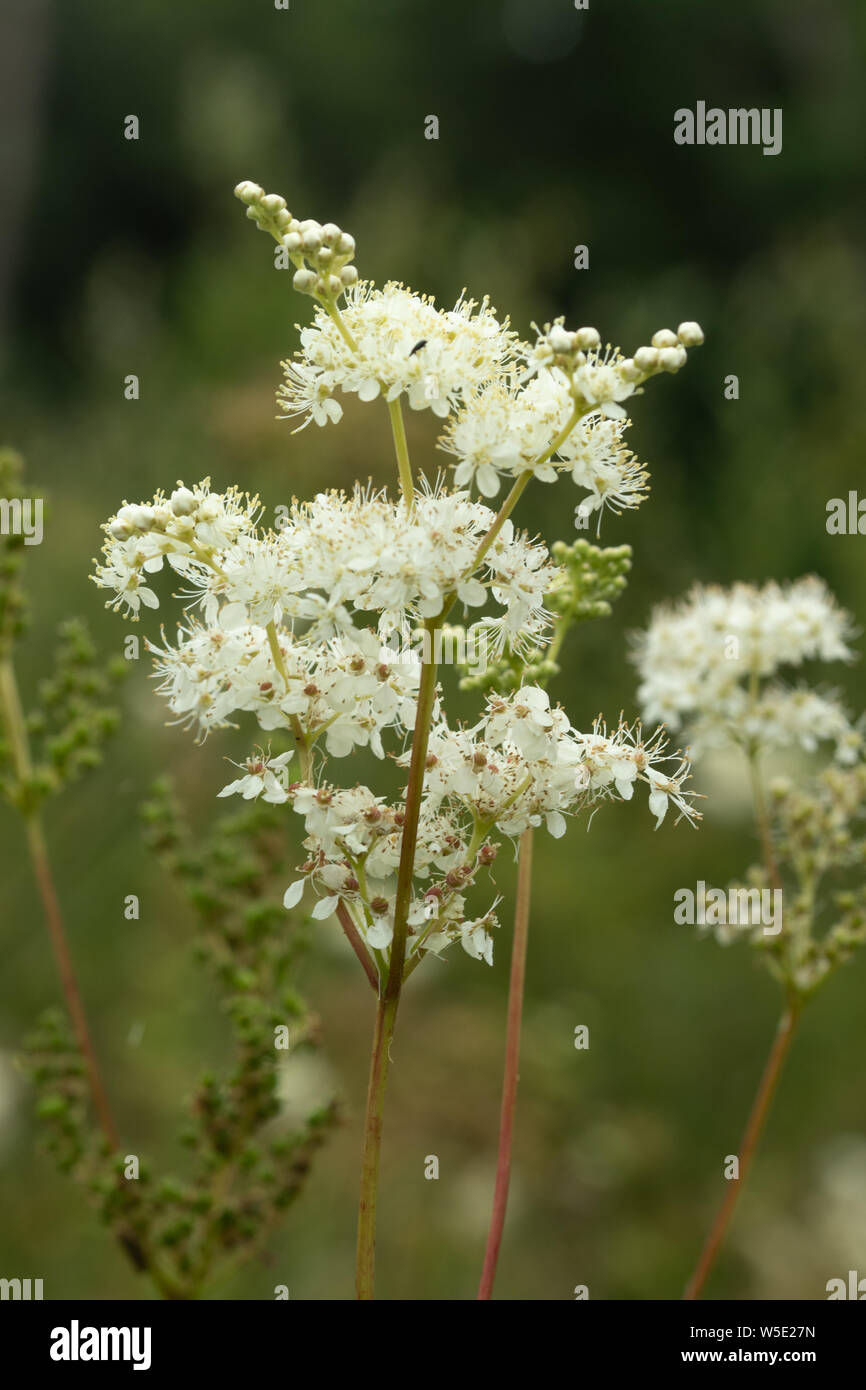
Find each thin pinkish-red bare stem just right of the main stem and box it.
[478,826,532,1298]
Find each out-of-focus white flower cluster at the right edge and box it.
[635,577,862,763]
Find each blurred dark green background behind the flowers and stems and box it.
[0,0,866,1300]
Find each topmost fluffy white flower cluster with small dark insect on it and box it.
[277,281,517,430]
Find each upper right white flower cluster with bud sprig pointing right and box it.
[441,320,703,520]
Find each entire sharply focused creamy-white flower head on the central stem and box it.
[93,181,702,980]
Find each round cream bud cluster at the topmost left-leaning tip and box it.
[235,179,357,300]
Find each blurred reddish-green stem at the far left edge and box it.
[0,657,120,1150]
